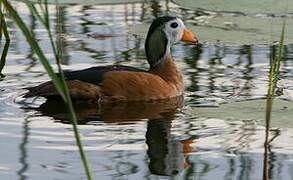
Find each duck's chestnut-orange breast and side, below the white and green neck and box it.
[101,57,183,101]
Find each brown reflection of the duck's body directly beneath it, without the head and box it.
[37,96,183,124]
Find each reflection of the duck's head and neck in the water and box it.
[146,119,192,176]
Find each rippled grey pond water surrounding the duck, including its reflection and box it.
[0,1,293,180]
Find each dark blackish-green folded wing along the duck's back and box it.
[57,65,146,85]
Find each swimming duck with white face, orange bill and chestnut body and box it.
[24,16,198,102]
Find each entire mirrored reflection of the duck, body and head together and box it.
[33,97,192,176]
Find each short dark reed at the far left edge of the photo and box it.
[0,3,10,80]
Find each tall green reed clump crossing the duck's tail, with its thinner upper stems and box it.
[0,0,93,180]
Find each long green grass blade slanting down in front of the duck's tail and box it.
[2,0,92,180]
